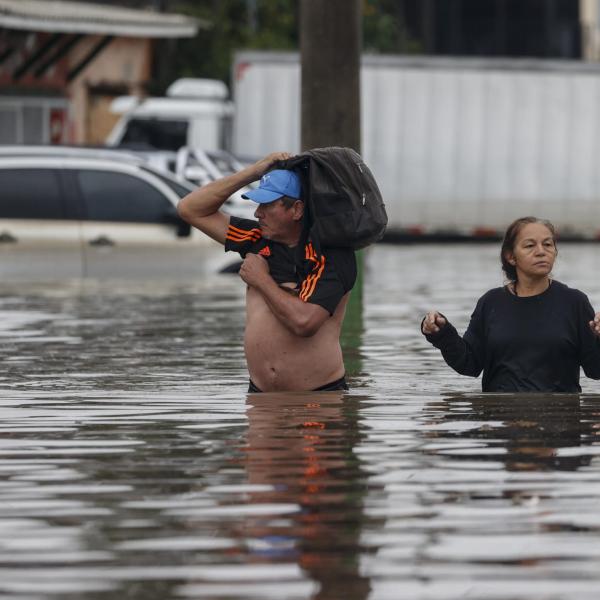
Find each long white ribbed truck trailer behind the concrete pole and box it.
[233,52,600,238]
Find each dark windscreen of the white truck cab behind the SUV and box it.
[119,119,188,151]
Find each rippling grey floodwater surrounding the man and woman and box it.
[0,244,600,600]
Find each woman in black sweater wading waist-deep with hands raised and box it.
[421,217,600,392]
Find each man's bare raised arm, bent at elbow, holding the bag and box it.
[177,152,290,244]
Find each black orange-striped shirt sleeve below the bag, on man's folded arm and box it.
[299,252,356,315]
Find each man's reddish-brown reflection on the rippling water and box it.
[244,392,369,599]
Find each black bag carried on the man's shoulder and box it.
[276,147,387,250]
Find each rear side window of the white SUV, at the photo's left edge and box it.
[0,169,67,219]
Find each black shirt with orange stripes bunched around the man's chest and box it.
[225,217,356,314]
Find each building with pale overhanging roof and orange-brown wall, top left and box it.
[0,0,202,144]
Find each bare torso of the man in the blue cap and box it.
[244,287,349,392]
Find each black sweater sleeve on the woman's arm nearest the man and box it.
[425,299,485,377]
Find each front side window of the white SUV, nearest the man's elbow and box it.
[77,169,176,223]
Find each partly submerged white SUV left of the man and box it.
[0,146,237,281]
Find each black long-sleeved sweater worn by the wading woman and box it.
[425,281,600,392]
